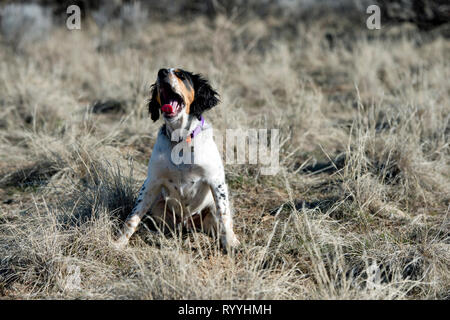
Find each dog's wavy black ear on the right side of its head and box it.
[189,74,220,119]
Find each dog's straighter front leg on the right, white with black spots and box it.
[210,179,240,248]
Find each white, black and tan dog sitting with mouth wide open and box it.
[117,68,240,249]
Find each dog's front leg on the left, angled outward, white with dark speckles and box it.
[116,179,161,247]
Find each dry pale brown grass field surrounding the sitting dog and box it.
[0,5,450,299]
